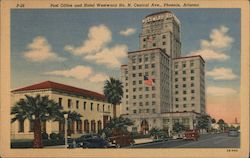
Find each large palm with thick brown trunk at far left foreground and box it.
[11,94,62,148]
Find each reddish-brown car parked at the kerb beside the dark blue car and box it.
[109,134,135,148]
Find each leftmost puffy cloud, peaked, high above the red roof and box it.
[23,36,66,62]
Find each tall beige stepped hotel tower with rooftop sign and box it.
[121,11,206,134]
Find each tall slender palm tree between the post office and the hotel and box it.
[104,77,123,118]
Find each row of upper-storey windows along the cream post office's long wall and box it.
[58,98,110,111]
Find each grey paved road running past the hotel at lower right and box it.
[133,133,240,148]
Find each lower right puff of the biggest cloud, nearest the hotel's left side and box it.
[83,45,128,68]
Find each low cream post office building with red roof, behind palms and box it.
[11,81,113,139]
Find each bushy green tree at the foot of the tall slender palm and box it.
[102,117,134,137]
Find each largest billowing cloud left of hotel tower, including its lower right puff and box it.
[65,25,128,68]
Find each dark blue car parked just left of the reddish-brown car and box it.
[82,137,115,148]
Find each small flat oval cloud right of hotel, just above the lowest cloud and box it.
[206,67,237,80]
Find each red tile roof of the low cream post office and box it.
[12,81,105,100]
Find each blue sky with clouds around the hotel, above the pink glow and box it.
[11,9,240,122]
